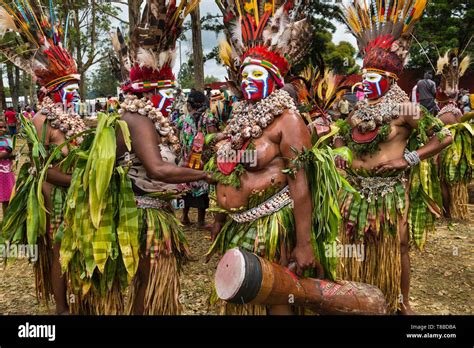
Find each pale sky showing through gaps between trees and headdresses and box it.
[112,0,357,81]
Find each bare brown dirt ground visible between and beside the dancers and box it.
[0,205,474,315]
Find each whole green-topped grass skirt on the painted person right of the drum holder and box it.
[337,174,406,313]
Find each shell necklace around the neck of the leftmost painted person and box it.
[39,97,87,145]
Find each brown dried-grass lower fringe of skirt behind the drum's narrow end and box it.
[337,230,401,314]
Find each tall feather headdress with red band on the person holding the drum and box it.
[216,0,312,91]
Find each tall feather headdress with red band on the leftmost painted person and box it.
[0,0,80,94]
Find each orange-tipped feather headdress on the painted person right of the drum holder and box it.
[343,0,427,78]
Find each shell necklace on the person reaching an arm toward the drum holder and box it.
[119,95,180,154]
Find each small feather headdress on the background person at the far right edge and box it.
[436,49,471,101]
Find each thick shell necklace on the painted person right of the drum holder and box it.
[351,83,409,133]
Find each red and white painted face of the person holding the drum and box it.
[241,65,275,101]
